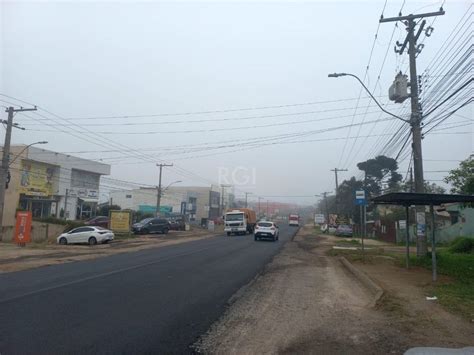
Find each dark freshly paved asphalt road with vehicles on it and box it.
[0,226,296,355]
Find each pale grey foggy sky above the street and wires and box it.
[0,0,473,203]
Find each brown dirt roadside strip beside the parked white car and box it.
[0,229,218,273]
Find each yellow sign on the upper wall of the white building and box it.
[19,160,55,196]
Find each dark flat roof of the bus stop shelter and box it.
[371,192,474,206]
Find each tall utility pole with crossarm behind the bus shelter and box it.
[380,7,445,256]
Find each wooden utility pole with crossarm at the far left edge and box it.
[0,106,36,240]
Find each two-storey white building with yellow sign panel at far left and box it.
[3,145,110,226]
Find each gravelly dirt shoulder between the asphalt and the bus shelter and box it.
[195,227,474,354]
